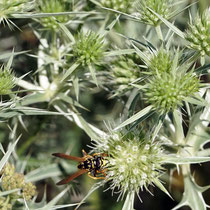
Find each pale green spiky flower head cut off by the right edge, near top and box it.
[185,8,210,56]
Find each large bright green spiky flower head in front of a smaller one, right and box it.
[145,71,200,113]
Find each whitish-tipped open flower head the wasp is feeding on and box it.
[91,132,163,196]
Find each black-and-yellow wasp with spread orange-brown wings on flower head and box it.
[52,150,107,185]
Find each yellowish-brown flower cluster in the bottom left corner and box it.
[0,163,36,209]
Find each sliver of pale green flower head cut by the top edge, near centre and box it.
[101,0,134,12]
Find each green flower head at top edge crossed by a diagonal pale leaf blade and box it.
[135,0,172,26]
